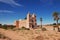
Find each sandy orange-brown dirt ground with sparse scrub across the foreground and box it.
[0,28,60,40]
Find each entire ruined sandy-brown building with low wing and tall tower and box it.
[15,12,37,28]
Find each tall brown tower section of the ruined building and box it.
[27,12,37,28]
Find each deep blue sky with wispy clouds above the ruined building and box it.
[0,0,60,24]
